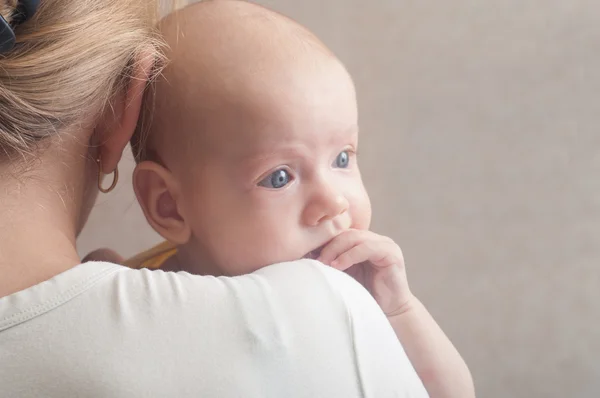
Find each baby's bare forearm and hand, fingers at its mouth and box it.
[319,230,475,398]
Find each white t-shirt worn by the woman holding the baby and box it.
[0,260,427,398]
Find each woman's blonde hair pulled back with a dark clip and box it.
[0,0,169,162]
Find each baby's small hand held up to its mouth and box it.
[318,229,413,317]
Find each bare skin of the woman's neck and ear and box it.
[0,56,153,297]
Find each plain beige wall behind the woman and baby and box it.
[80,0,600,398]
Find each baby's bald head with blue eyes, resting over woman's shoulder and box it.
[133,1,371,275]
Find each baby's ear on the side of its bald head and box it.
[133,161,191,245]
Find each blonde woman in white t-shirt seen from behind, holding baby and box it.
[0,0,422,397]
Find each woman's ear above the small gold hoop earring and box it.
[95,53,155,174]
